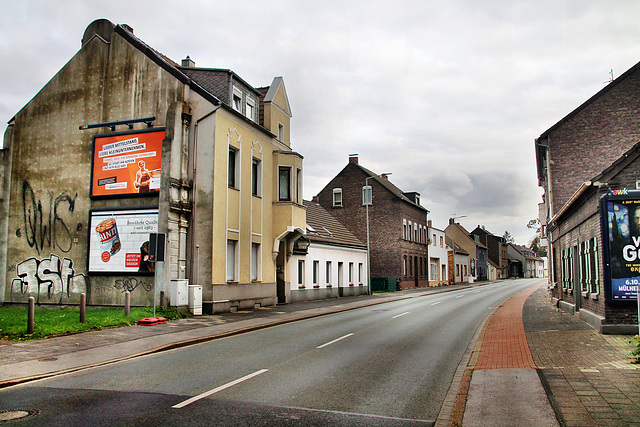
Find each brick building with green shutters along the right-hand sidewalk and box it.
[535,60,640,333]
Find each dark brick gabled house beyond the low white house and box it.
[315,156,429,290]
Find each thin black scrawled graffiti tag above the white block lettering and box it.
[16,181,81,254]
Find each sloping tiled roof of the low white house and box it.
[304,200,367,249]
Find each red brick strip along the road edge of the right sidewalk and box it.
[475,283,540,370]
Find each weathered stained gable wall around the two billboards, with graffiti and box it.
[4,25,184,305]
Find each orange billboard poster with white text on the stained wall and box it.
[91,130,164,197]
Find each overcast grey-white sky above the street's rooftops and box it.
[0,0,640,244]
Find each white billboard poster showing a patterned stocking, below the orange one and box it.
[89,209,158,273]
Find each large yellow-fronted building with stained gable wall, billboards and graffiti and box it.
[0,19,305,312]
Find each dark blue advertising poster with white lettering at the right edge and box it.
[602,191,640,301]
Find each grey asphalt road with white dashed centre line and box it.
[0,279,539,426]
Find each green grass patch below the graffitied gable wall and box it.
[0,306,189,341]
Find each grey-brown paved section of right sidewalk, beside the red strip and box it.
[523,288,640,427]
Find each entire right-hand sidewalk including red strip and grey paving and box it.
[449,285,640,426]
